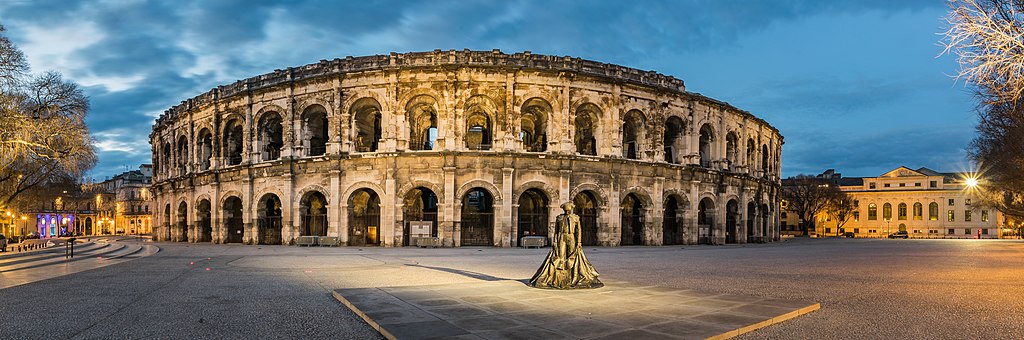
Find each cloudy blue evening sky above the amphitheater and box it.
[0,0,977,180]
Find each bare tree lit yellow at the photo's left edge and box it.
[0,23,96,209]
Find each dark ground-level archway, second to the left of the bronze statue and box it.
[460,187,495,246]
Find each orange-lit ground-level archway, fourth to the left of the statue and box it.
[348,188,381,246]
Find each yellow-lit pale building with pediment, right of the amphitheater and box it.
[780,167,1004,239]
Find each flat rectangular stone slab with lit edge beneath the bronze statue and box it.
[334,281,820,339]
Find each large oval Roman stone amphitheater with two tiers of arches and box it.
[150,50,782,247]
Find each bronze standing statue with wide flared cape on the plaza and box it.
[529,202,604,289]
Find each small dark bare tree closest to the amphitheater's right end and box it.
[782,175,842,236]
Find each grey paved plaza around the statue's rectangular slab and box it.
[0,239,1024,339]
